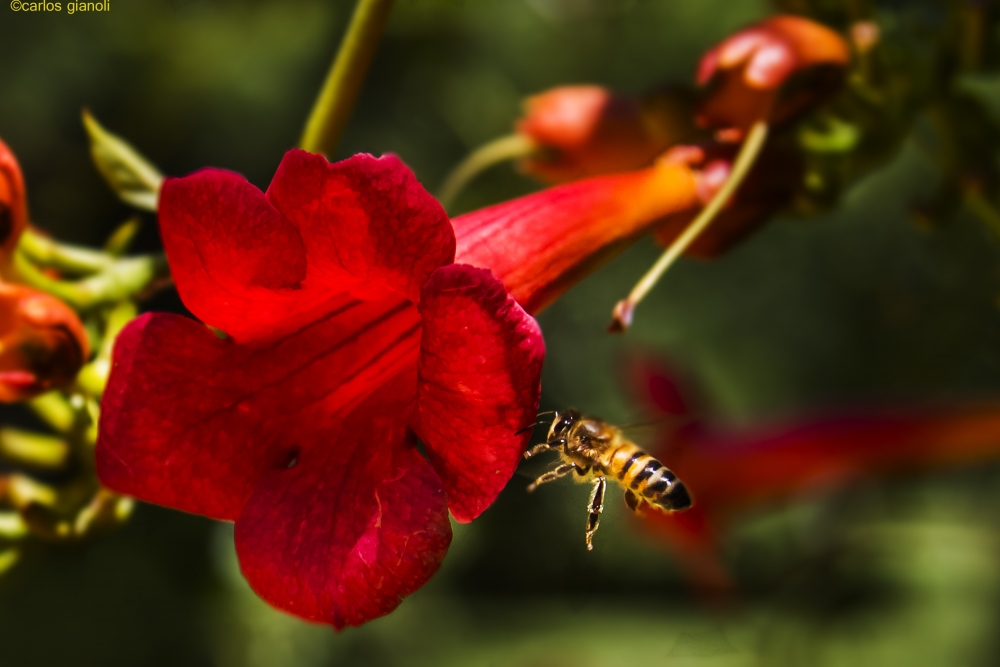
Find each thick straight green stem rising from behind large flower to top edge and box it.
[299,0,393,156]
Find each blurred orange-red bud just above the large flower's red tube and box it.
[517,86,694,183]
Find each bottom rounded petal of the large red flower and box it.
[236,378,451,628]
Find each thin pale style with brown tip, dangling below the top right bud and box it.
[608,120,767,333]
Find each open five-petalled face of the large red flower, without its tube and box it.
[97,150,544,628]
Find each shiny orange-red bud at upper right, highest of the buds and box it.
[698,16,850,141]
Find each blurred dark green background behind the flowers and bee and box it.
[0,0,1000,667]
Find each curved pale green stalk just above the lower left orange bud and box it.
[14,252,170,311]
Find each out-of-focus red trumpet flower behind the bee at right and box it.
[628,365,1000,592]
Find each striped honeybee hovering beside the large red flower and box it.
[524,410,692,550]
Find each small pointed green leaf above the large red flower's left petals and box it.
[83,109,163,211]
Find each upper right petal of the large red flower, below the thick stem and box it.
[267,150,455,302]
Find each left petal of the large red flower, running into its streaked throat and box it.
[97,295,420,520]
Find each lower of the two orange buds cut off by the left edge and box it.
[0,283,90,403]
